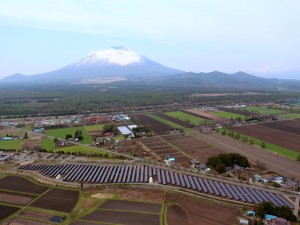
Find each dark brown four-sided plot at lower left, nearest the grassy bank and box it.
[32,188,79,212]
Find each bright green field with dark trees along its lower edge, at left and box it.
[45,127,93,144]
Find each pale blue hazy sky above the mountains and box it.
[0,0,300,77]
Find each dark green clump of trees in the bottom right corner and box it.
[255,202,297,222]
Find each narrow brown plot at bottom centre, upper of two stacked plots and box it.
[100,200,161,213]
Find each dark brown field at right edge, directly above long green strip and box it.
[234,125,300,152]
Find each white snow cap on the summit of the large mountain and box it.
[73,47,142,66]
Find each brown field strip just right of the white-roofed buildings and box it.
[129,114,171,134]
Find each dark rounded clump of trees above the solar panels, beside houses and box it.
[206,153,250,173]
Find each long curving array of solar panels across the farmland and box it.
[20,164,294,208]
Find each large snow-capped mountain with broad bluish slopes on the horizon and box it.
[0,47,182,83]
